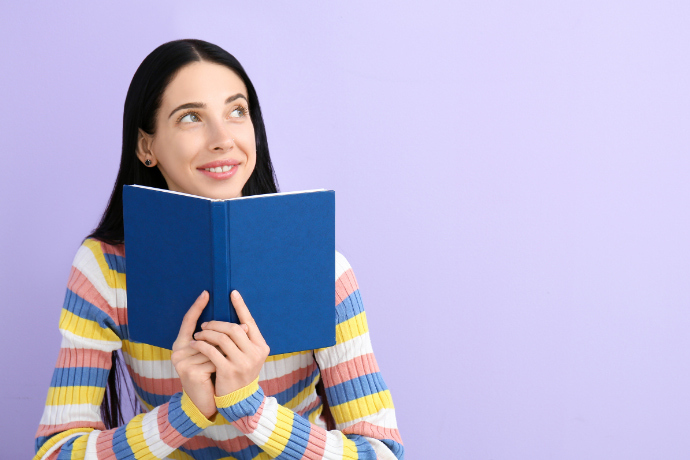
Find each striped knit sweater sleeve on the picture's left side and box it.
[34,239,213,460]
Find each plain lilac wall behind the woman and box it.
[0,1,690,460]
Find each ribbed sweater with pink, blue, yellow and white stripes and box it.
[34,239,403,460]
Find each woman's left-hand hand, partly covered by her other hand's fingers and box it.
[170,291,216,418]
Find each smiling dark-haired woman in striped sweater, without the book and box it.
[35,40,403,459]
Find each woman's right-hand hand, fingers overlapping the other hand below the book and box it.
[190,291,270,396]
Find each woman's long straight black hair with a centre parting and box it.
[87,39,278,428]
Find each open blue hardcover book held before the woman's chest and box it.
[123,185,335,355]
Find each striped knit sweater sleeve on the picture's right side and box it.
[216,254,404,460]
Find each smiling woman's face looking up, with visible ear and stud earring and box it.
[137,61,256,199]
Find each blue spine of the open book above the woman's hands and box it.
[210,201,236,321]
